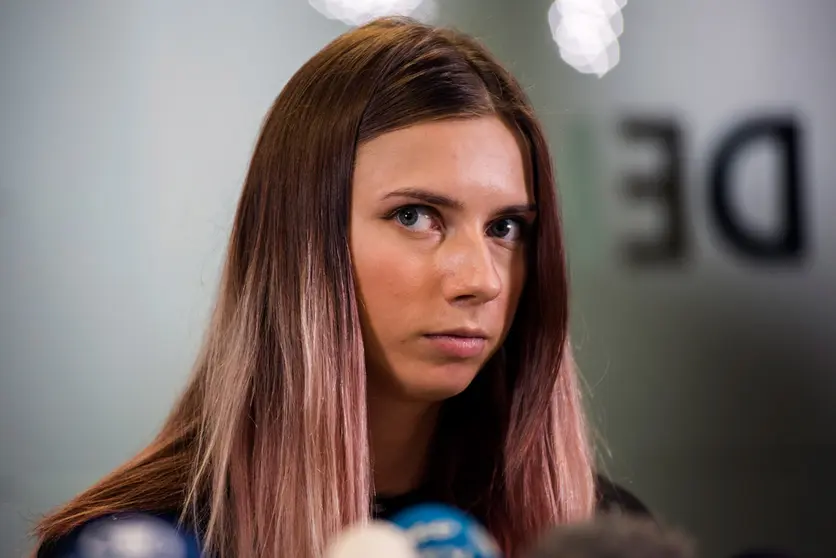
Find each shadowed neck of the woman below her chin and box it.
[367,394,441,496]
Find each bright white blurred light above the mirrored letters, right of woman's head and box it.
[549,0,627,77]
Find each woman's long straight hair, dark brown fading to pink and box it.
[36,18,594,558]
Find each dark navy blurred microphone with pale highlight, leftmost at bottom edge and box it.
[36,513,200,558]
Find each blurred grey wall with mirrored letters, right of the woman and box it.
[515,4,836,556]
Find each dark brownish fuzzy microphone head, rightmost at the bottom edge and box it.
[525,514,694,558]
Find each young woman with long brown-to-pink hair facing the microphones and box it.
[32,15,648,558]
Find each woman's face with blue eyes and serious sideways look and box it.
[350,117,535,401]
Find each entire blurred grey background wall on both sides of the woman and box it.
[0,0,836,557]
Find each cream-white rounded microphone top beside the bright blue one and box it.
[324,521,420,558]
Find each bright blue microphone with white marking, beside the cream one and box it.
[390,504,502,558]
